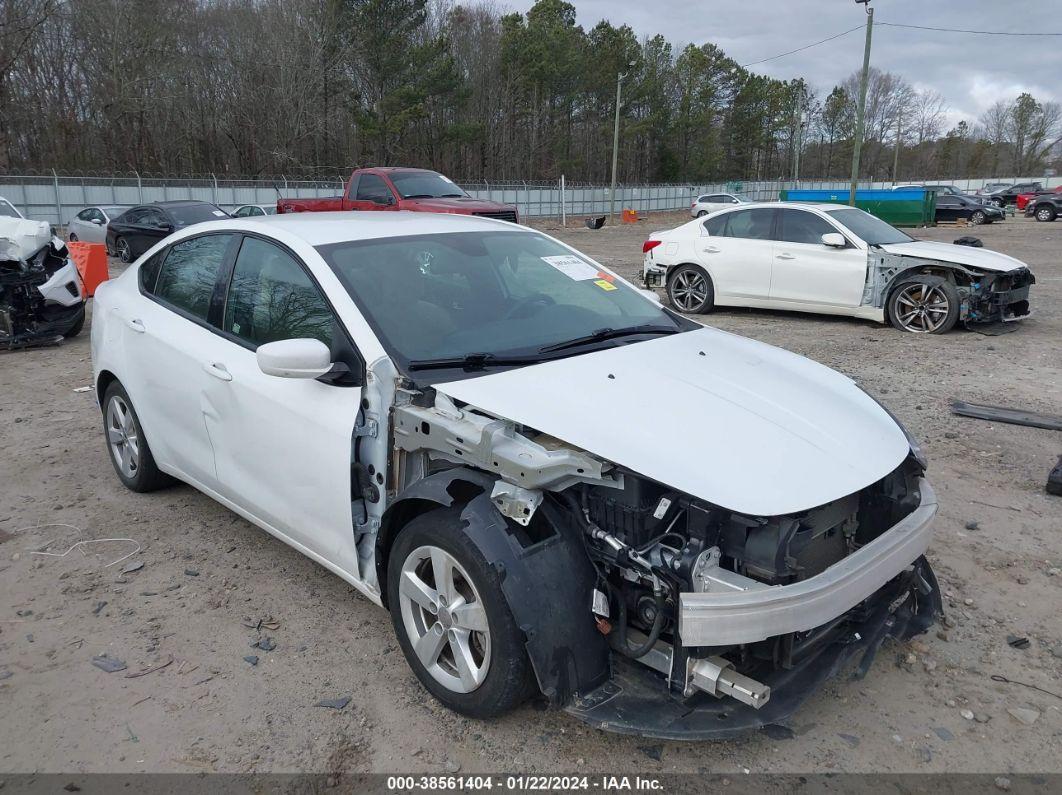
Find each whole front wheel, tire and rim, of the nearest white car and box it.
[388,508,533,718]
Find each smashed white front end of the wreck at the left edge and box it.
[0,218,85,349]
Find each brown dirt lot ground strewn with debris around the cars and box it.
[0,215,1062,773]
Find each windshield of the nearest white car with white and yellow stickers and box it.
[318,231,695,369]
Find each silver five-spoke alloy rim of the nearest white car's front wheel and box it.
[398,546,491,693]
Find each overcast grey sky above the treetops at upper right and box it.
[508,0,1062,124]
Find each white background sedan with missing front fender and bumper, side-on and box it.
[641,202,1035,333]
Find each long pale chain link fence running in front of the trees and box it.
[0,172,1062,226]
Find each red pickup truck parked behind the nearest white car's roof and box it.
[276,168,519,223]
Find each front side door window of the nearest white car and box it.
[222,238,335,349]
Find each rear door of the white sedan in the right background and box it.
[697,207,775,304]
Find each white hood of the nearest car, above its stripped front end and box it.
[434,328,910,516]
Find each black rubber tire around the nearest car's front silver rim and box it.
[388,508,535,718]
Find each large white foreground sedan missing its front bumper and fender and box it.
[92,212,941,738]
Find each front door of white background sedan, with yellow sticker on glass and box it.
[771,208,867,309]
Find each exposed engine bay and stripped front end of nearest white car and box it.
[392,390,940,737]
